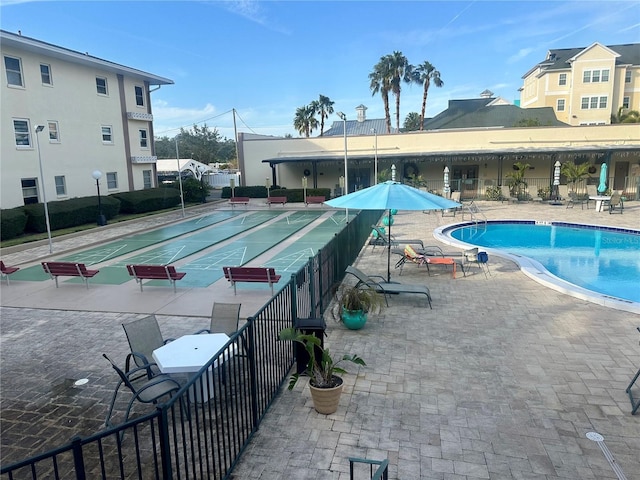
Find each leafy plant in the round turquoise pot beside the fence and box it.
[332,285,384,330]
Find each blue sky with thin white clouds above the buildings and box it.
[0,0,640,138]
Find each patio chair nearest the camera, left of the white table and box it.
[102,353,180,430]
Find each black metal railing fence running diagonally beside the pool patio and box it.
[0,211,382,480]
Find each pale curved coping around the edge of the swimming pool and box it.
[433,219,640,314]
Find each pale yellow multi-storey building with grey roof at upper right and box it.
[520,42,640,125]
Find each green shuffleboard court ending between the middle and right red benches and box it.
[172,211,326,287]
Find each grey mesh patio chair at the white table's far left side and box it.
[122,315,173,379]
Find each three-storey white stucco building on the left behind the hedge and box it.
[0,30,173,208]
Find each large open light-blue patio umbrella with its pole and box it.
[324,180,462,282]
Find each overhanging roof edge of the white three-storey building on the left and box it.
[0,30,173,85]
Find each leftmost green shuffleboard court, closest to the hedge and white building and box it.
[11,211,245,282]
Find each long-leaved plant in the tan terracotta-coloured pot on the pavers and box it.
[278,328,366,415]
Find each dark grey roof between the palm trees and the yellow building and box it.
[424,98,566,130]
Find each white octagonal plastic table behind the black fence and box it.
[153,333,234,402]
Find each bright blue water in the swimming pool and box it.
[448,222,640,303]
